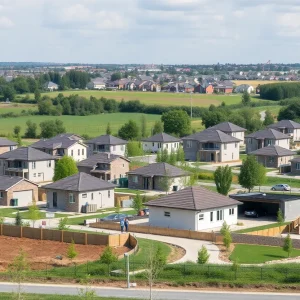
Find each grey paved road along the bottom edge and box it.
[0,283,300,300]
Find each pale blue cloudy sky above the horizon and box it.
[0,0,300,64]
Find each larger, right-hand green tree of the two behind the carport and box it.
[239,155,265,192]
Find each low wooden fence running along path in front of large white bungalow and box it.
[89,222,216,242]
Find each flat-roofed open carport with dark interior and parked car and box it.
[229,193,300,221]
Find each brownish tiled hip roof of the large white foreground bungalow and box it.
[145,186,241,210]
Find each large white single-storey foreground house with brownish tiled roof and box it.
[145,186,240,231]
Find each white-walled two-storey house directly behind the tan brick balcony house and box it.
[86,134,128,156]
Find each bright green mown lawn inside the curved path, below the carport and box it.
[230,244,300,264]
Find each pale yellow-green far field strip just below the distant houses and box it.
[24,90,258,107]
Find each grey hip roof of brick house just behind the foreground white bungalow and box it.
[127,163,190,177]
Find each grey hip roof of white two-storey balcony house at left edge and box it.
[0,147,55,161]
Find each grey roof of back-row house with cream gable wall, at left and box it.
[30,133,82,149]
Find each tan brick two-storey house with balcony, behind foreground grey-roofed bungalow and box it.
[77,153,130,182]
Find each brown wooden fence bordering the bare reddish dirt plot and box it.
[0,224,137,248]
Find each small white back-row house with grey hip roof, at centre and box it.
[142,132,181,153]
